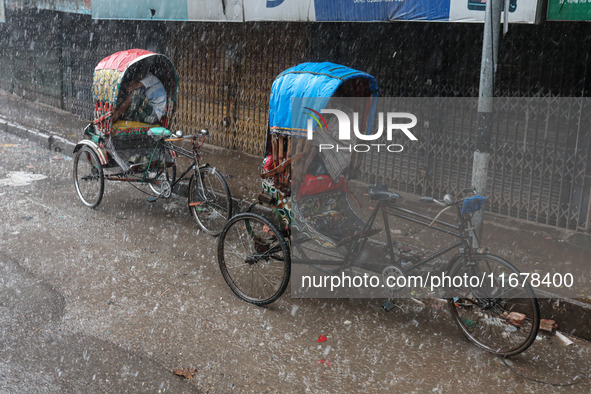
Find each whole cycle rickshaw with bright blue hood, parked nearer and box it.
[218,63,540,356]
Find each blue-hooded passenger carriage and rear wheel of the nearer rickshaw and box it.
[218,62,378,305]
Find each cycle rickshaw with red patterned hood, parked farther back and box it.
[73,49,232,235]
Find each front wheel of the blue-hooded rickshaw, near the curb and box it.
[447,254,540,356]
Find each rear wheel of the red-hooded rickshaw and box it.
[73,146,105,208]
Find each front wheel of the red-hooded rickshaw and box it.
[188,167,232,236]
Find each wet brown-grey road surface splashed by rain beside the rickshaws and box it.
[0,134,591,393]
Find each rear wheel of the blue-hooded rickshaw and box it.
[218,212,291,305]
